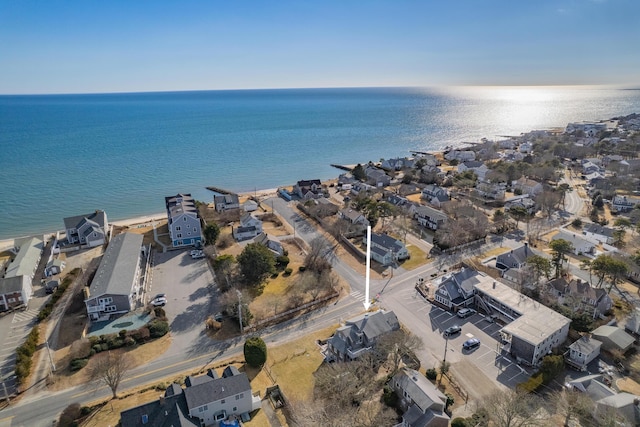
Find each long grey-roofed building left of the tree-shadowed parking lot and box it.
[84,233,143,321]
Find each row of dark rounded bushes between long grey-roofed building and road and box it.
[70,320,169,371]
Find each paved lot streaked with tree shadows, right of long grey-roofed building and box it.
[147,249,217,355]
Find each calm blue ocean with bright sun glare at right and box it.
[0,87,640,239]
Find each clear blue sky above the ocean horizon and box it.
[0,0,640,94]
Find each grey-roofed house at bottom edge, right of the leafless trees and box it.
[390,368,450,427]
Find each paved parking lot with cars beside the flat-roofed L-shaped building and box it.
[383,288,530,398]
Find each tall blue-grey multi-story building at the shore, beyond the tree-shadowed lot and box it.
[164,194,202,248]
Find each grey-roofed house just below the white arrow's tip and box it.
[325,310,400,362]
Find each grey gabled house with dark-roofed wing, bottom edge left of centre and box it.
[120,366,261,427]
